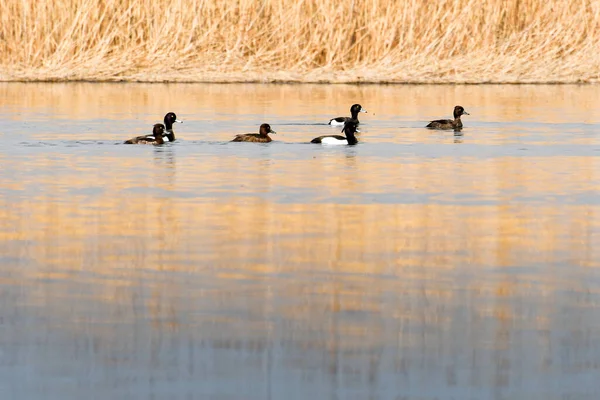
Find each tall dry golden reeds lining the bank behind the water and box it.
[0,0,600,82]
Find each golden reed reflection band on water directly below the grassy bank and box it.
[0,82,600,130]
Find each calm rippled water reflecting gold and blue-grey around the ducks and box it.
[0,83,600,400]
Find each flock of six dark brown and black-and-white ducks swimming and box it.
[125,104,469,145]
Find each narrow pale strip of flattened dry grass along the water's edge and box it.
[0,65,600,85]
